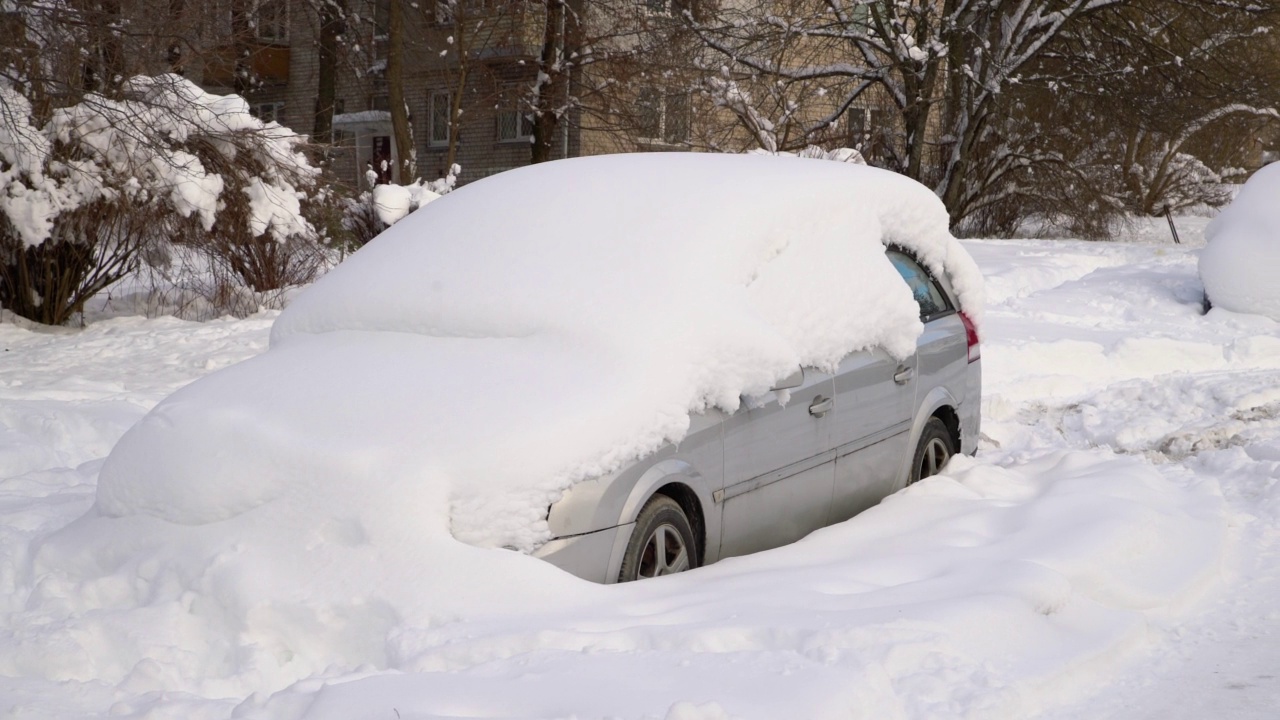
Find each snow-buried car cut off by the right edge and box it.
[1199,164,1280,320]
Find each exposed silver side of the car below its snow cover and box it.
[535,247,982,583]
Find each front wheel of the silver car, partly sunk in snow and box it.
[618,495,698,583]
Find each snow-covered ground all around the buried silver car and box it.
[0,221,1280,720]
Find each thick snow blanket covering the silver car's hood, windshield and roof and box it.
[97,154,982,550]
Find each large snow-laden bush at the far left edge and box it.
[0,76,317,324]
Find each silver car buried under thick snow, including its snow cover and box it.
[97,154,982,583]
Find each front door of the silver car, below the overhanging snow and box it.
[717,369,835,557]
